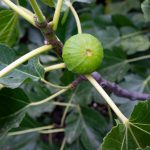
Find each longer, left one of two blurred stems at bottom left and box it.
[8,125,54,136]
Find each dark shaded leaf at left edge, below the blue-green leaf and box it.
[0,88,30,138]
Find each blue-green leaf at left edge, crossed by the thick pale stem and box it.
[0,45,44,88]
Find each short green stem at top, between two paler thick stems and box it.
[29,0,45,23]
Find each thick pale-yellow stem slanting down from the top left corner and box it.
[2,0,36,26]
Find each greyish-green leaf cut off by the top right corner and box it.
[141,0,150,21]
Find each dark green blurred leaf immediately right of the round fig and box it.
[99,48,130,81]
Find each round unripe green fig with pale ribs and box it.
[62,34,103,74]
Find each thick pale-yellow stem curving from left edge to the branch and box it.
[0,45,52,78]
